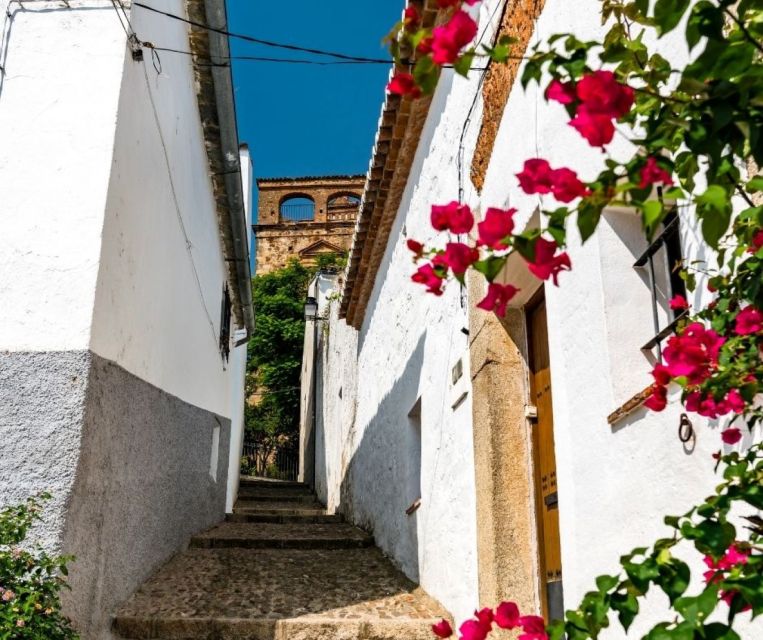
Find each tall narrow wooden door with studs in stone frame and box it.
[527,299,564,620]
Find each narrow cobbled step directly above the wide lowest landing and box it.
[190,522,374,549]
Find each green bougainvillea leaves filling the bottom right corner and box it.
[549,444,763,640]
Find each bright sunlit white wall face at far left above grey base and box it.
[0,0,125,351]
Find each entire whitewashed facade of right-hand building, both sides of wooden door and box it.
[308,0,762,639]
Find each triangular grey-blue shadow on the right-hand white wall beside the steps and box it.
[340,333,426,581]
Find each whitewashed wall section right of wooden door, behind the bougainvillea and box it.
[475,0,761,638]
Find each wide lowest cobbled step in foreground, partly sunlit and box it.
[114,547,447,640]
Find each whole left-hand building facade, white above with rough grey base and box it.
[0,0,253,640]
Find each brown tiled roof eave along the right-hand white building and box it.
[339,0,439,329]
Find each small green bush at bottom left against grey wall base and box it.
[0,494,79,640]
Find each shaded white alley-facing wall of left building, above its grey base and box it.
[91,0,244,417]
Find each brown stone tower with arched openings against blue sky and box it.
[253,176,366,275]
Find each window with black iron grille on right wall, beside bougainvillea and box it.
[633,208,687,359]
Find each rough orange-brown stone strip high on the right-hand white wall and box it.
[471,0,545,191]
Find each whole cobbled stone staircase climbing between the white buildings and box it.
[113,479,447,640]
